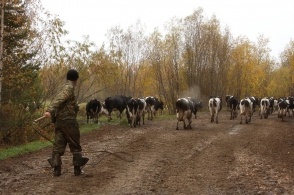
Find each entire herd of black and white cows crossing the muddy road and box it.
[86,95,294,130]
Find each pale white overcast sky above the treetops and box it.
[41,0,294,58]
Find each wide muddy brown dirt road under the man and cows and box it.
[0,111,294,195]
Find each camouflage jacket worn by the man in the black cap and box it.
[47,81,78,120]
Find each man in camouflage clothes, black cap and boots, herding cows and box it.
[44,69,89,176]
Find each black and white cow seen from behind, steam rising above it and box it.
[176,98,193,130]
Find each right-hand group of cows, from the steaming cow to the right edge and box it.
[176,95,294,129]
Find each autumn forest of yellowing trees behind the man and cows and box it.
[0,0,294,145]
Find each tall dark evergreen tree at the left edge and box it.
[1,0,39,105]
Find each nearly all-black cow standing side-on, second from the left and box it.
[105,95,131,121]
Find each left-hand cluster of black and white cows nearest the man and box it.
[86,95,163,127]
